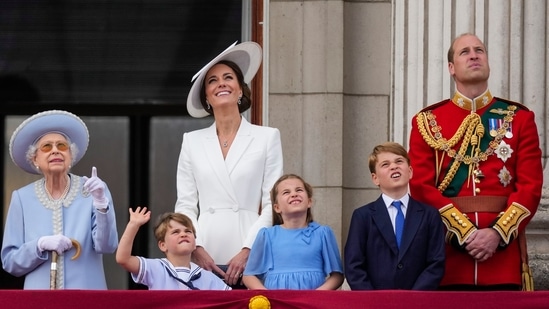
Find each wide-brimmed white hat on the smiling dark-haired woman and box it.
[187,42,263,118]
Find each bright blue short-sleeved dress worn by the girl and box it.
[244,222,343,290]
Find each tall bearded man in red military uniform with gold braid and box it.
[410,34,543,290]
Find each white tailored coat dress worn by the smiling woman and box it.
[175,118,282,264]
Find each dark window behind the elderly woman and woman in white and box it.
[0,0,257,289]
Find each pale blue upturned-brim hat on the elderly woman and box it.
[10,110,90,174]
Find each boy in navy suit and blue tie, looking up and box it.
[344,143,445,290]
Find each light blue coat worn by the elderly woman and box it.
[1,174,118,290]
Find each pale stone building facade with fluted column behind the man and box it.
[264,0,549,289]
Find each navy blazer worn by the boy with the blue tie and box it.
[344,196,445,290]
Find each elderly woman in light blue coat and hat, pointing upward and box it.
[1,110,118,289]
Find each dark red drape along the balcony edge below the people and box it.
[0,290,549,309]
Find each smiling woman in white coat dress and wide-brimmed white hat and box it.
[175,42,283,288]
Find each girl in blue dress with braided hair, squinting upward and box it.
[242,174,343,290]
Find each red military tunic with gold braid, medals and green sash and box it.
[409,91,543,286]
